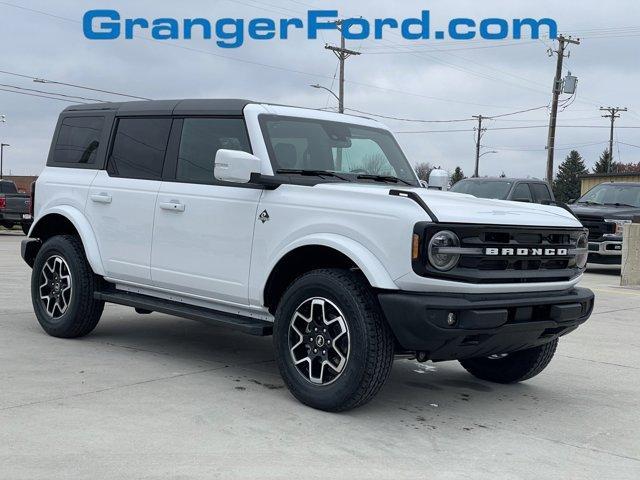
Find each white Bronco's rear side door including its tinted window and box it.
[86,117,172,284]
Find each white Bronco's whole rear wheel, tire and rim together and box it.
[31,235,104,338]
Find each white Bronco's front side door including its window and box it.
[151,117,262,304]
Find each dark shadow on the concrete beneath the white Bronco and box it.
[86,305,569,420]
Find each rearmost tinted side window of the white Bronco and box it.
[53,117,104,165]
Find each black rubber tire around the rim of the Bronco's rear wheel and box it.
[31,235,104,338]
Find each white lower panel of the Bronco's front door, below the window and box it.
[151,182,262,305]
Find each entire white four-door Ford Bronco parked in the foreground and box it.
[22,100,594,411]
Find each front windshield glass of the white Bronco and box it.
[260,115,419,186]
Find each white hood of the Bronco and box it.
[315,183,582,227]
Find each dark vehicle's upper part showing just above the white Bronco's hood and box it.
[451,178,555,204]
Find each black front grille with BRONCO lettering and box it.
[413,223,585,283]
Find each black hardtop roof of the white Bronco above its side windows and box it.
[63,98,256,116]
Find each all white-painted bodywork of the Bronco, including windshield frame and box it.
[35,104,581,318]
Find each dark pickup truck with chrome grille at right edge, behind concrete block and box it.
[569,183,640,265]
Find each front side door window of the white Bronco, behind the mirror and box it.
[176,118,251,183]
